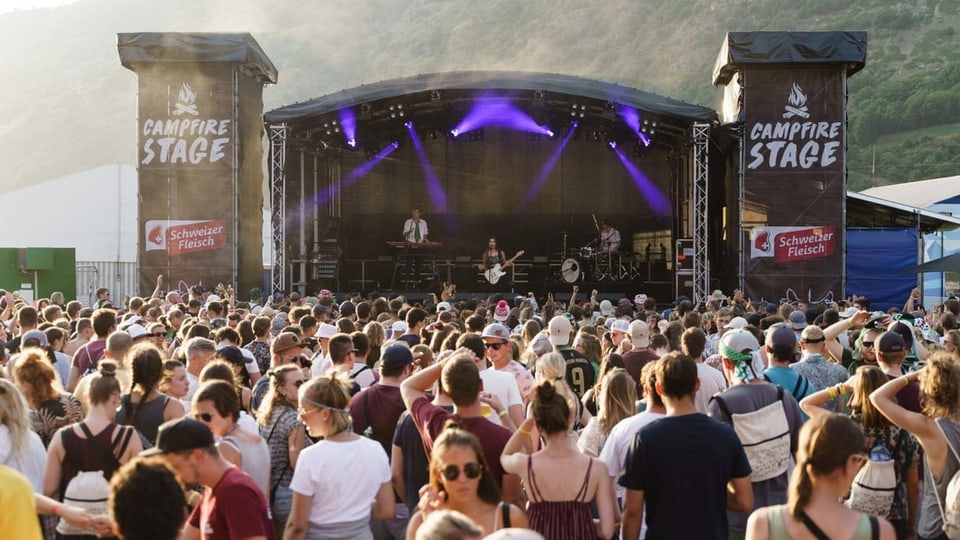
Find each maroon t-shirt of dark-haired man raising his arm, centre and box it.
[410,397,511,487]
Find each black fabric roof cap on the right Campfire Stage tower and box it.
[713,32,867,84]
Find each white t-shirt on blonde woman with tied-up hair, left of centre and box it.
[290,437,390,525]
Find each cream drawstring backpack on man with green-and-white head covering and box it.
[710,386,790,482]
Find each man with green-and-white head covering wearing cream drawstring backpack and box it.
[707,329,803,536]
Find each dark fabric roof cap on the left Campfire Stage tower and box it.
[117,32,277,84]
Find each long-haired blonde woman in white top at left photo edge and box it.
[0,379,47,492]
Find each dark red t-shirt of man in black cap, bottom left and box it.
[190,467,275,540]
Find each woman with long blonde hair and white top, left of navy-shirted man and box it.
[577,368,637,457]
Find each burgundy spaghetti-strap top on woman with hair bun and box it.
[527,456,597,540]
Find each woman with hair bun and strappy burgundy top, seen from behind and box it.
[500,382,616,540]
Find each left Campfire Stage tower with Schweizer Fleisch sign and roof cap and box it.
[118,33,277,291]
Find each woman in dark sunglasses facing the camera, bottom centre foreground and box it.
[407,423,528,540]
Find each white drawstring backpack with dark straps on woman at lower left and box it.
[57,422,134,536]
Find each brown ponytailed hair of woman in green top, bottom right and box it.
[787,413,865,519]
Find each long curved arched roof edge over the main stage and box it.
[264,71,717,124]
